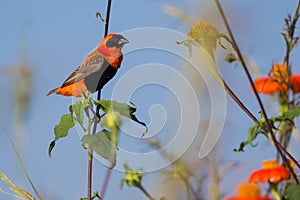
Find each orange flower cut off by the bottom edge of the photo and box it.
[225,183,272,200]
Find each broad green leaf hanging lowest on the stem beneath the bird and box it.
[81,129,117,167]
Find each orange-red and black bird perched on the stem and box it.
[47,33,128,97]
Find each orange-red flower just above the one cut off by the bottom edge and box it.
[249,160,290,183]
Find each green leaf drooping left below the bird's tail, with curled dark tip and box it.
[48,113,75,157]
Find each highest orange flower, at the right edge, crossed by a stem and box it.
[254,63,300,94]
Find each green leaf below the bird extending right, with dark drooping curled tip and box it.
[95,100,148,136]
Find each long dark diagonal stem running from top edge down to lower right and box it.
[215,0,299,183]
